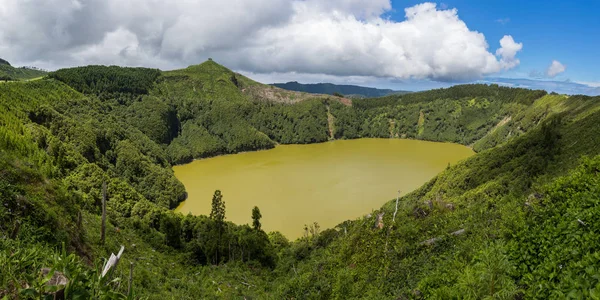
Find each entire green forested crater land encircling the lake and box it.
[0,61,600,299]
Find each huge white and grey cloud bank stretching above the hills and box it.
[0,0,523,81]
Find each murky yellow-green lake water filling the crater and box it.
[173,139,474,239]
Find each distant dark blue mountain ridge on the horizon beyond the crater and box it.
[271,81,410,98]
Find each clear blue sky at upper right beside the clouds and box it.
[388,0,600,92]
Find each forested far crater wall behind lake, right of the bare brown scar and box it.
[331,84,547,146]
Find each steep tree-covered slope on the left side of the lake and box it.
[0,68,272,299]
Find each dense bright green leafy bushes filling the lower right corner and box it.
[511,157,600,299]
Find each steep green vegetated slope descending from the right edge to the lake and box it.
[279,96,600,299]
